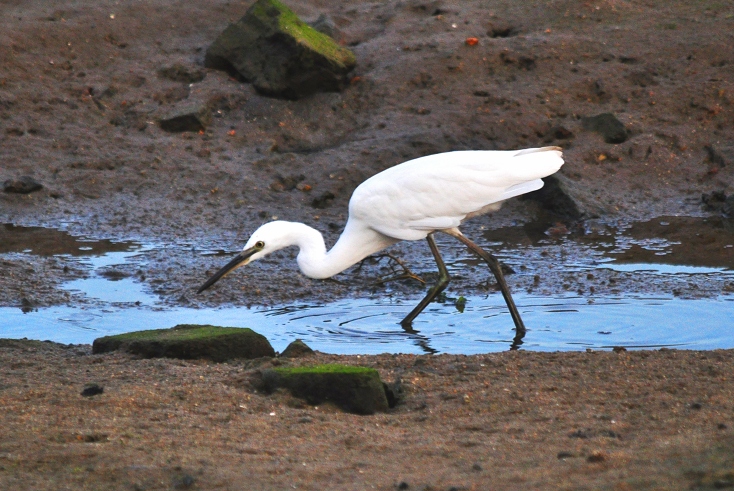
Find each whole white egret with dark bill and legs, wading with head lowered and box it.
[198,147,563,335]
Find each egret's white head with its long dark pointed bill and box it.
[196,220,294,293]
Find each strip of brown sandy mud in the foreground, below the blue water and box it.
[0,341,734,490]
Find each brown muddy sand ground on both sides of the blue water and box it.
[0,0,734,489]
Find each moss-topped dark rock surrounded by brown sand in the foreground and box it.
[262,364,388,414]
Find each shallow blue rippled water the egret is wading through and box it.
[0,221,734,354]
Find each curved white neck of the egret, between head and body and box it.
[296,220,399,278]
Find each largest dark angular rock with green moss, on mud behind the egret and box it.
[204,0,356,99]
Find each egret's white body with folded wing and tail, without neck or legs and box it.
[349,147,563,240]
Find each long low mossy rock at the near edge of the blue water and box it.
[92,324,275,362]
